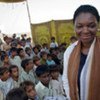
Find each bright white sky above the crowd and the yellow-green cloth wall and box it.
[0,0,100,34]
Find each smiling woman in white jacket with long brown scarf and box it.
[63,5,100,100]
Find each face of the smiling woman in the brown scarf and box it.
[74,13,98,44]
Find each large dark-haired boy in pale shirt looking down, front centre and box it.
[35,65,65,100]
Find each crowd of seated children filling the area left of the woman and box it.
[0,34,66,100]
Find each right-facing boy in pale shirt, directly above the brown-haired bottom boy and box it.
[21,59,36,83]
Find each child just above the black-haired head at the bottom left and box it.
[9,65,21,87]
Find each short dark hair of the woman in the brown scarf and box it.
[73,5,100,23]
